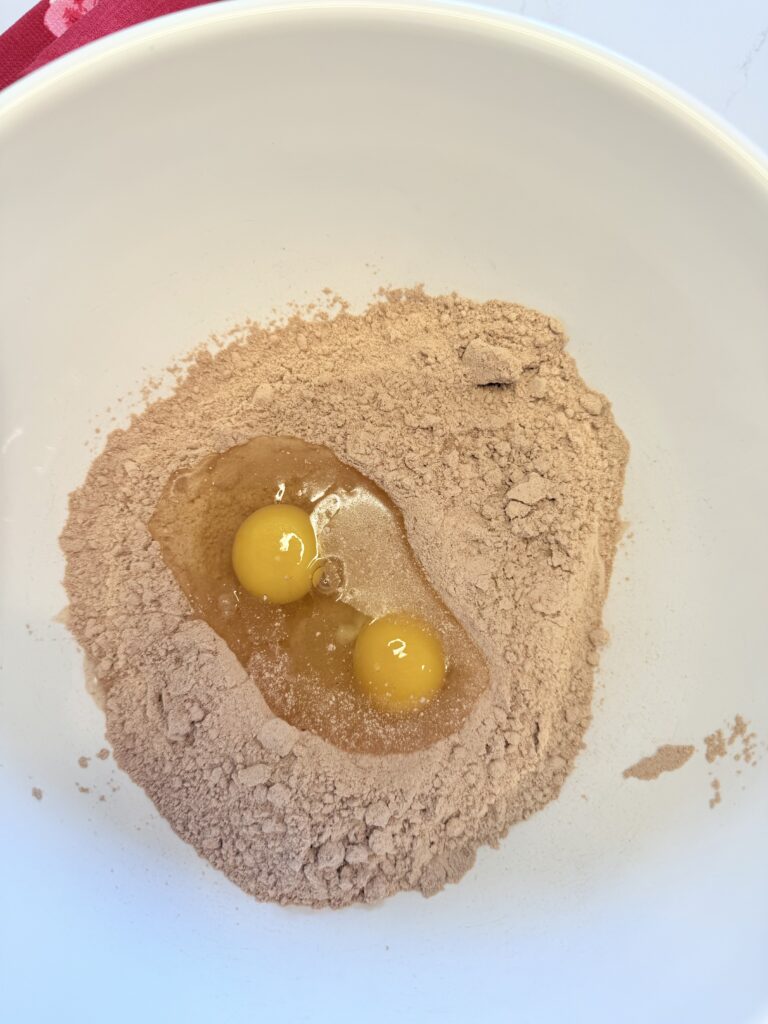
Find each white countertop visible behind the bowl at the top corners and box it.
[0,0,768,151]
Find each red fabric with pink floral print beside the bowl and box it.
[0,0,214,89]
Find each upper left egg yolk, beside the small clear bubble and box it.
[232,504,317,604]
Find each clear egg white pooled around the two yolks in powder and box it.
[150,437,488,754]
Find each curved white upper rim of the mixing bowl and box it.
[0,0,768,193]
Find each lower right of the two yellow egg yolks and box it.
[352,614,445,712]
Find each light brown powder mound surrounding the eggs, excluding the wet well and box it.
[61,290,628,906]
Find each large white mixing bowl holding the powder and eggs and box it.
[0,3,768,1024]
